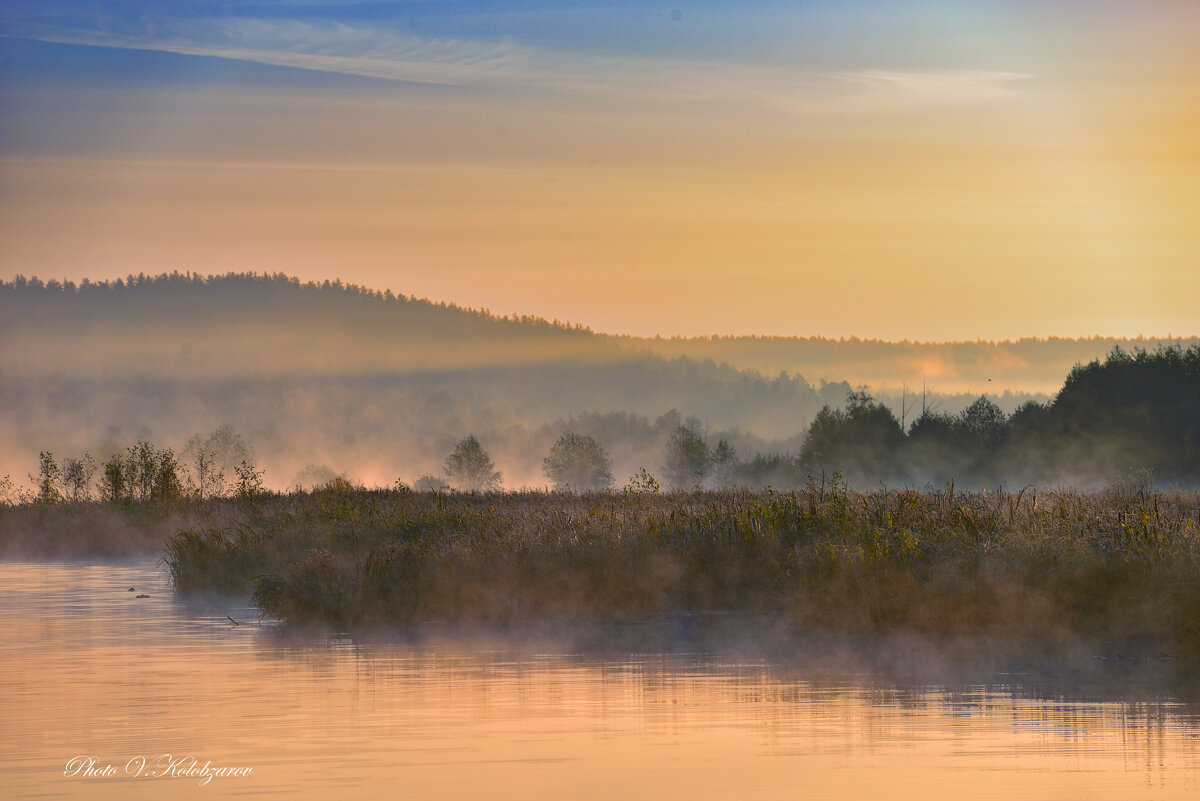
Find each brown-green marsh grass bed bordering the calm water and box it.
[159,483,1200,652]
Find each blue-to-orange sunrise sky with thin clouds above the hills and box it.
[0,0,1200,341]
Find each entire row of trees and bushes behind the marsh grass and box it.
[0,347,1200,504]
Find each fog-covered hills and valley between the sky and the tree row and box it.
[0,275,1196,489]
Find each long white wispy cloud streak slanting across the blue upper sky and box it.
[8,18,1031,114]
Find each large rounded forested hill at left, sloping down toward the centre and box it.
[0,273,604,378]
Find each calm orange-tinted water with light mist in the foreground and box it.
[0,564,1200,800]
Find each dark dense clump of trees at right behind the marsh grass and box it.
[788,347,1200,486]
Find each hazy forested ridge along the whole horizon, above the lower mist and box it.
[0,273,1185,397]
